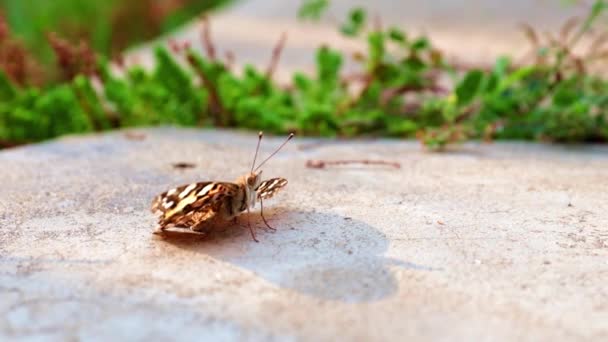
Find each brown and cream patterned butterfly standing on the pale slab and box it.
[152,132,294,242]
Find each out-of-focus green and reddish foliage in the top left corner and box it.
[0,0,229,79]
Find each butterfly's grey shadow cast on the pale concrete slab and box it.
[154,208,432,303]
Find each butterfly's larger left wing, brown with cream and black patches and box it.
[152,182,239,228]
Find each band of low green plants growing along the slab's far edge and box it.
[0,0,608,150]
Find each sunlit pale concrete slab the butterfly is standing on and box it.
[0,128,608,341]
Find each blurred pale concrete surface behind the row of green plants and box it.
[127,0,589,83]
